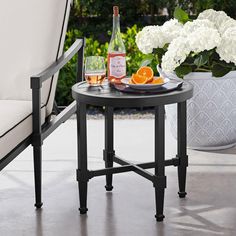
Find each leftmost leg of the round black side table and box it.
[76,103,89,214]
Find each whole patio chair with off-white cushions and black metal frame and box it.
[0,0,84,208]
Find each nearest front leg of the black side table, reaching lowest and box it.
[154,105,166,221]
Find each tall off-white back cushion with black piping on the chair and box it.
[0,0,71,114]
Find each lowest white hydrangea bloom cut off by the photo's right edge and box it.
[216,27,236,64]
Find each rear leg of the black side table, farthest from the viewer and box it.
[103,107,115,191]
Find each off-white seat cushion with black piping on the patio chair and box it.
[0,100,45,159]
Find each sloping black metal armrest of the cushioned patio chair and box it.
[30,39,84,89]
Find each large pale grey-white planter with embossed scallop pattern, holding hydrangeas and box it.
[167,71,236,150]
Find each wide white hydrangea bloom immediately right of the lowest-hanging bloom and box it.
[187,27,221,53]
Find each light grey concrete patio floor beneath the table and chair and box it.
[0,116,236,236]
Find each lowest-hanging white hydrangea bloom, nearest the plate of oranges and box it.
[161,36,191,72]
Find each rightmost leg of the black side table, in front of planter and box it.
[177,102,188,198]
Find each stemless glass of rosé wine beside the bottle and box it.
[85,56,106,86]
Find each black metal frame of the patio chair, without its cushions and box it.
[0,39,85,208]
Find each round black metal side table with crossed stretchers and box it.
[72,82,193,221]
